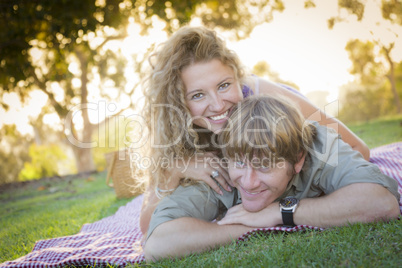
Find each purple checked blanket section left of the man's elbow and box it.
[0,195,144,268]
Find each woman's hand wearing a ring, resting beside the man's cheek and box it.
[168,152,233,195]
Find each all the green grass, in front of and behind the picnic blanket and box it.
[0,116,402,267]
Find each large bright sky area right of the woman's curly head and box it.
[226,0,402,100]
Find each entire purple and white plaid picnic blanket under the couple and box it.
[0,142,402,268]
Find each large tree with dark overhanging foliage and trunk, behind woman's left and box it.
[0,0,284,175]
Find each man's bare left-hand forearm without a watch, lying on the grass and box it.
[144,218,253,262]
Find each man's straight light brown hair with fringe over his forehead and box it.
[218,95,316,169]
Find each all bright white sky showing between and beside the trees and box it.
[0,0,402,133]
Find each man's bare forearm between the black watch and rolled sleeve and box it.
[294,183,400,227]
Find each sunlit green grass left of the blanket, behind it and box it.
[0,174,129,263]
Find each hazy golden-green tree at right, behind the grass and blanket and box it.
[339,39,402,122]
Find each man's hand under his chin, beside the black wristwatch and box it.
[218,202,282,228]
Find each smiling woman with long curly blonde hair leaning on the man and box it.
[140,27,369,233]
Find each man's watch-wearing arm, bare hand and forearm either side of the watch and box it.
[218,183,400,227]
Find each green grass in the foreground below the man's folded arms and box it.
[155,221,402,267]
